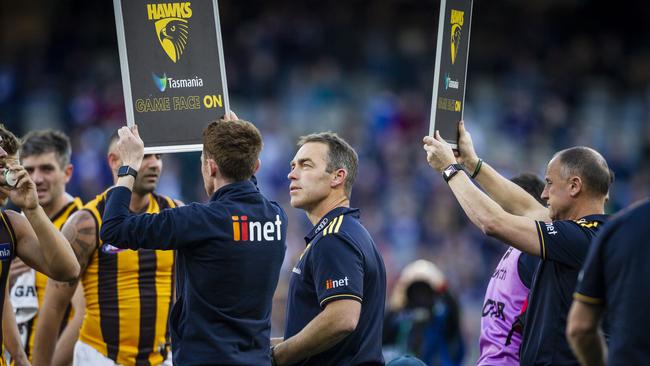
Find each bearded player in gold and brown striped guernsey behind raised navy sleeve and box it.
[33,133,180,365]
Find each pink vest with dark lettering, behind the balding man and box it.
[477,247,530,366]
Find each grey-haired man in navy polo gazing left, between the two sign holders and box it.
[272,132,386,366]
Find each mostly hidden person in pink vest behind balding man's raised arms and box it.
[476,174,545,366]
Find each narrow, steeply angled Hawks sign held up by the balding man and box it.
[429,0,472,148]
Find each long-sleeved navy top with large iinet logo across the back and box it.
[101,181,287,366]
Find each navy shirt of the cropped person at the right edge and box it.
[574,201,650,365]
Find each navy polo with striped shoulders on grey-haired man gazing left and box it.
[284,207,386,366]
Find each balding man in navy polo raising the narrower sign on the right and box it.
[424,121,611,365]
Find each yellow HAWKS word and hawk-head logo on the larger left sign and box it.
[147,2,192,63]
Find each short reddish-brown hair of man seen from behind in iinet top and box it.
[203,119,262,182]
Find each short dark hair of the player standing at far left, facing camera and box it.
[20,130,72,168]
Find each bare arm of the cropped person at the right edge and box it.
[566,300,607,365]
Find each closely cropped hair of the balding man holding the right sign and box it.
[555,146,614,196]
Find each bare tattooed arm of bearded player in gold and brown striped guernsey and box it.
[33,210,97,365]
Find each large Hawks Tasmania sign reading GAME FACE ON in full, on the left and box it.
[113,0,230,154]
